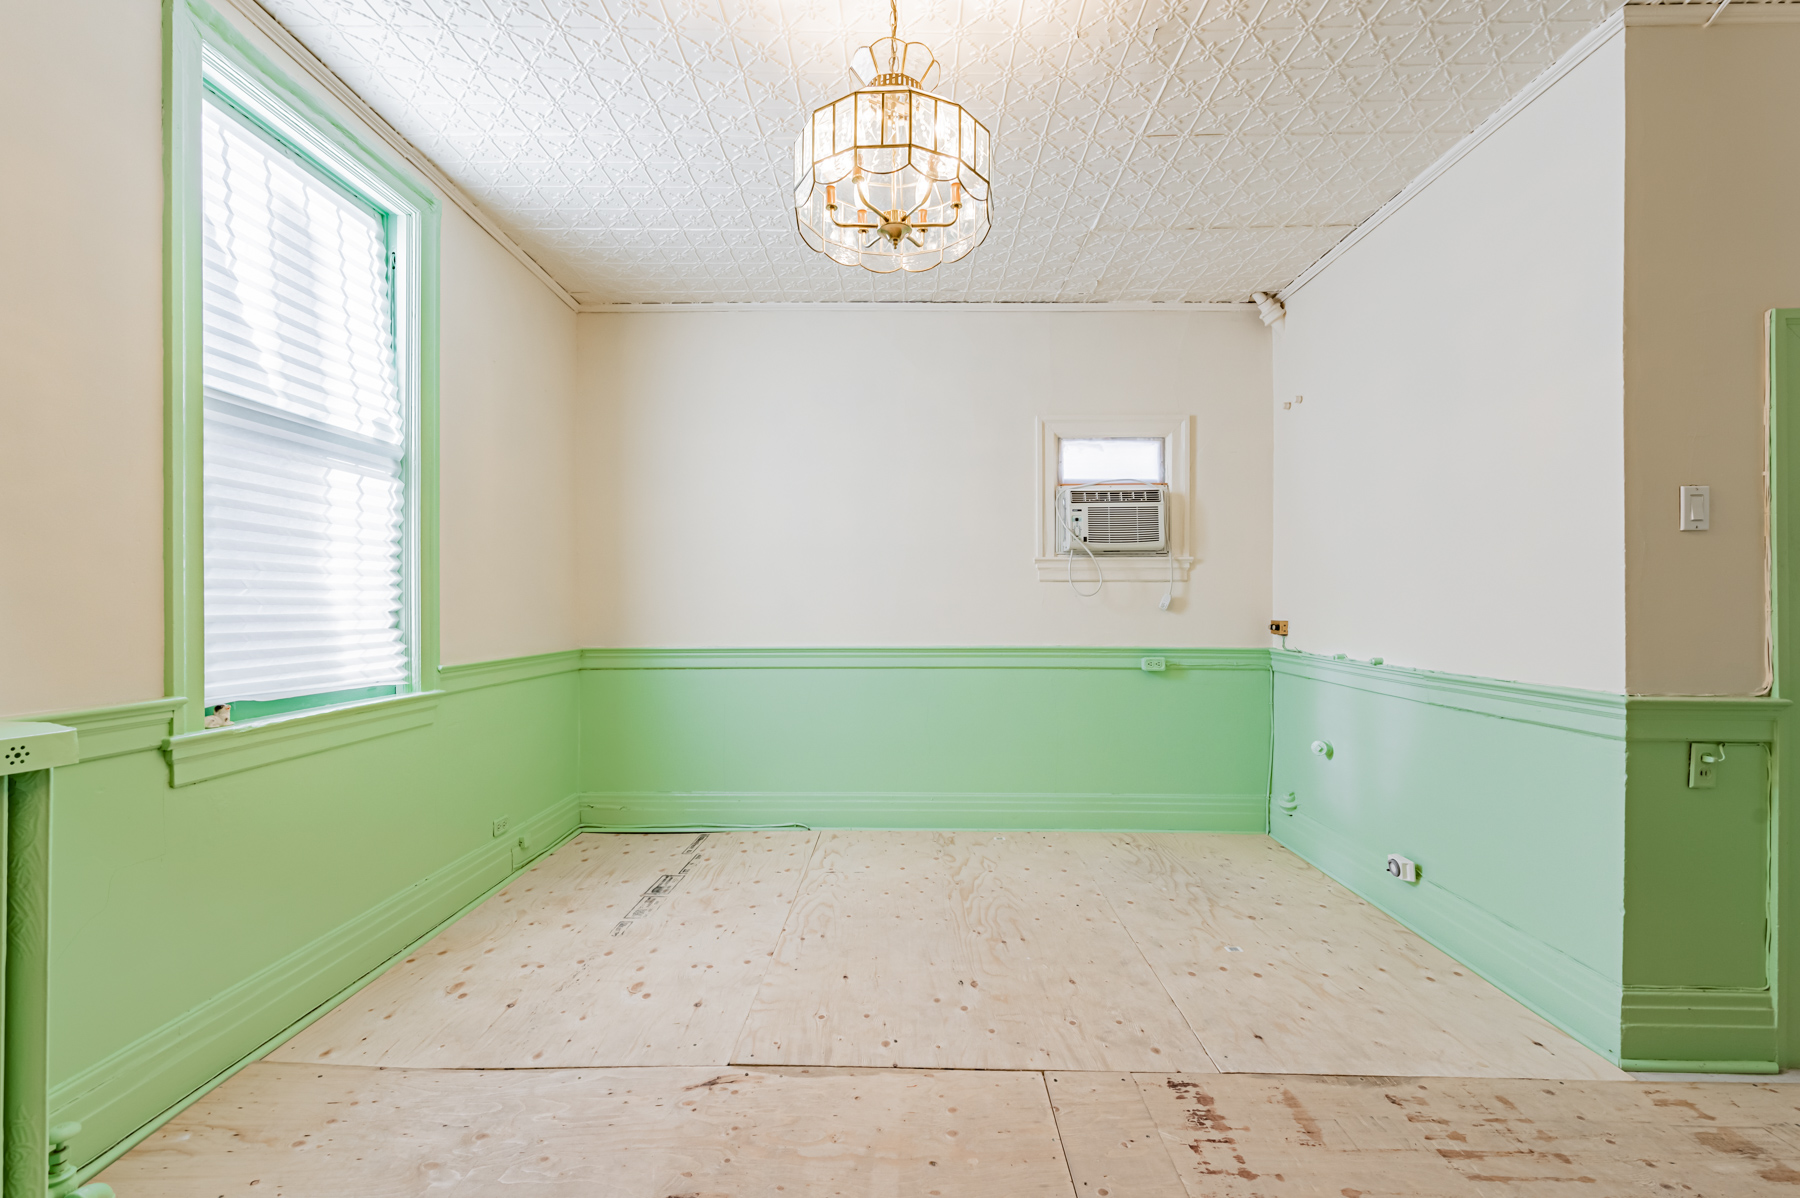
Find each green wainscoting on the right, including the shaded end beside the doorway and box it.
[1271,651,1787,1074]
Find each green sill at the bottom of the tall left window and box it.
[162,691,441,786]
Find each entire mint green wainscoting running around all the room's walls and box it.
[21,649,1787,1169]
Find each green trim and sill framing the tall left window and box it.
[164,0,441,748]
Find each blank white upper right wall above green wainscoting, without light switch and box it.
[1273,27,1634,691]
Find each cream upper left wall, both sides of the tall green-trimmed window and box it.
[0,0,574,714]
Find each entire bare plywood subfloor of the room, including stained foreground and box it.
[91,833,1764,1198]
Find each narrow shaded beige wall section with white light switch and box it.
[1625,5,1800,694]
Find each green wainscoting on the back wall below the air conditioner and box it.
[581,649,1269,833]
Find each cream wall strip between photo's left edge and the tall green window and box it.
[0,0,162,712]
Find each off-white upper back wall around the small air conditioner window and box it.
[578,304,1271,648]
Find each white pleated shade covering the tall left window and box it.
[202,95,409,705]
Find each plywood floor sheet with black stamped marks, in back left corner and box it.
[268,831,817,1068]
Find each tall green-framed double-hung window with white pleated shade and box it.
[169,0,437,732]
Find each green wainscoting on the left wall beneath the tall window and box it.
[35,653,580,1169]
